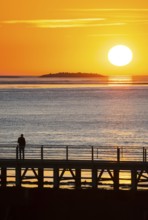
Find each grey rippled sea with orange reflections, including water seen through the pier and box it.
[0,77,148,189]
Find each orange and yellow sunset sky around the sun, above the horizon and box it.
[0,0,148,76]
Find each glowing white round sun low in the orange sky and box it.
[108,45,133,66]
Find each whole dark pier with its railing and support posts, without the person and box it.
[0,146,148,191]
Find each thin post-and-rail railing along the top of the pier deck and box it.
[0,145,148,162]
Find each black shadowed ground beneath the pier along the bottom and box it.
[0,188,148,220]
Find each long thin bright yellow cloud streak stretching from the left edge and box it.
[1,18,125,28]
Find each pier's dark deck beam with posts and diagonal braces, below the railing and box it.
[0,159,148,190]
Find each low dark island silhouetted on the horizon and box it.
[41,72,106,78]
